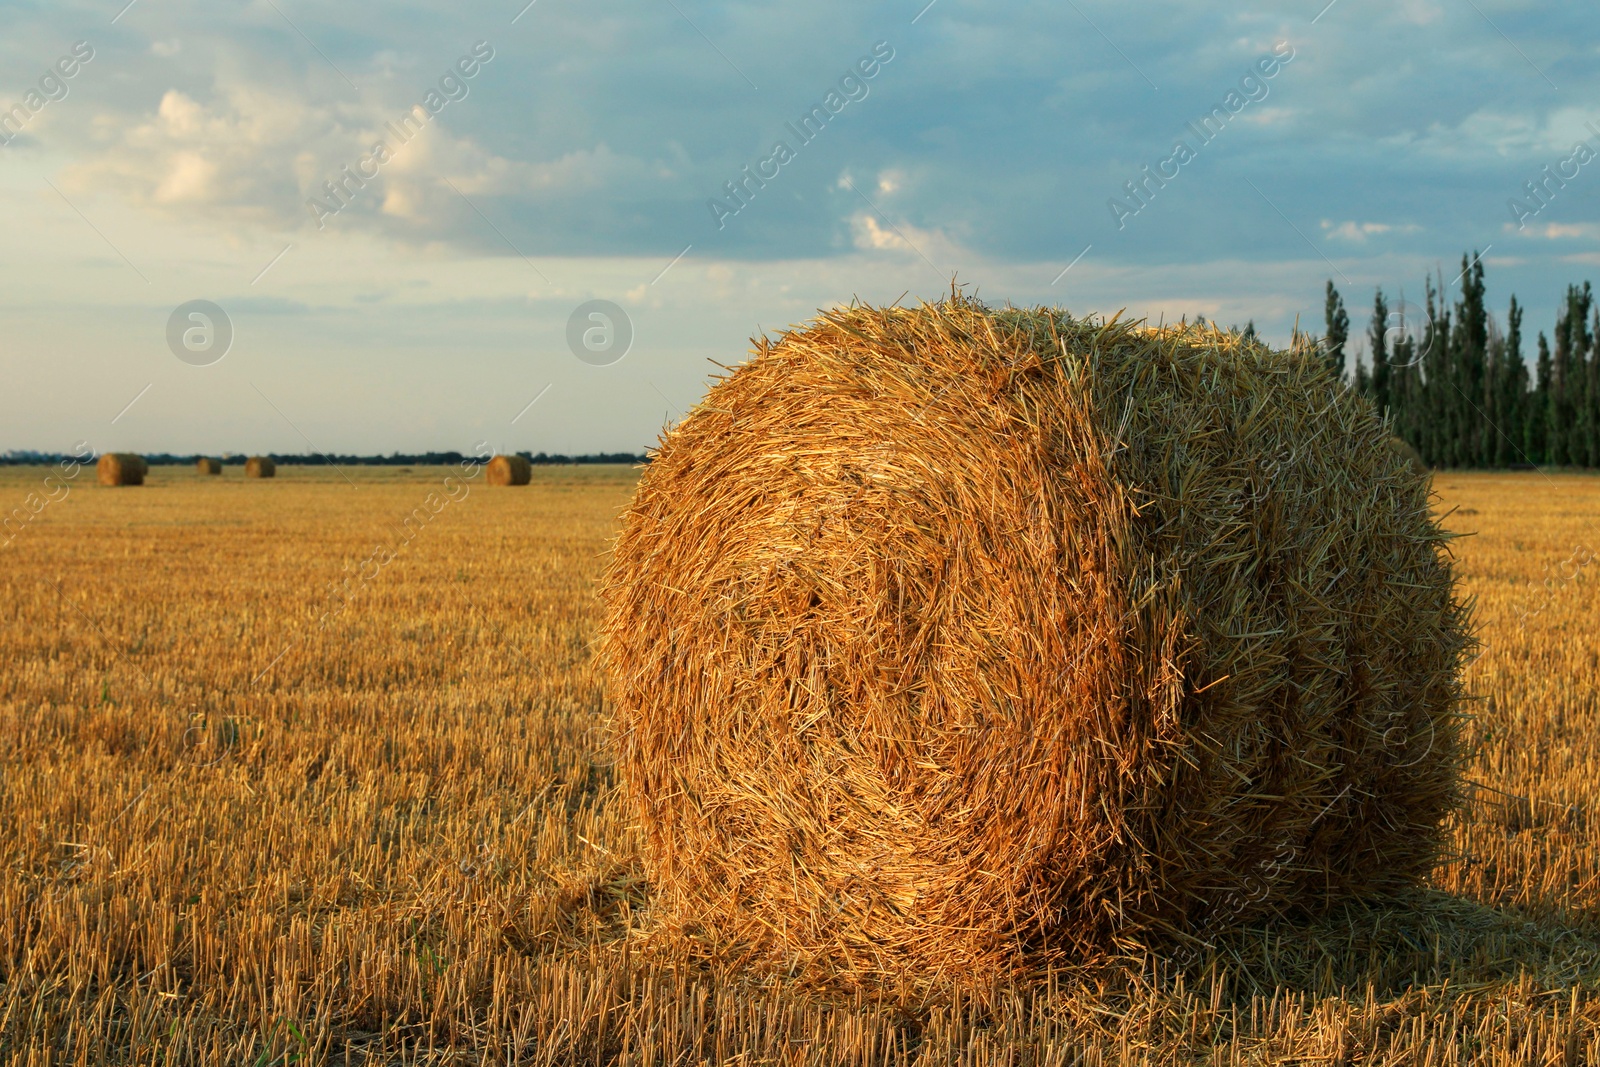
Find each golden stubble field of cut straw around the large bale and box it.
[0,467,1600,1065]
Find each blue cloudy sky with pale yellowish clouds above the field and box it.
[0,0,1600,453]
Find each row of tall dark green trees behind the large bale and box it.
[1296,253,1600,467]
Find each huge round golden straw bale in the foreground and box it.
[602,298,1470,984]
